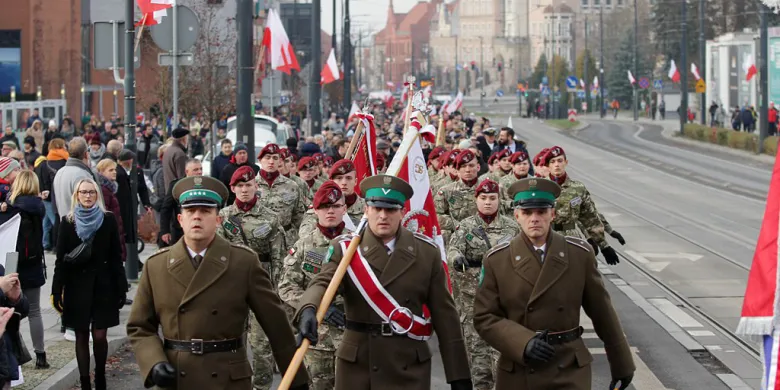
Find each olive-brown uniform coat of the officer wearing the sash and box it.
[295,228,470,390]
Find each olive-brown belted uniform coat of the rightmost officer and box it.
[474,232,635,390]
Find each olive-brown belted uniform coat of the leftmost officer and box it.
[127,236,308,390]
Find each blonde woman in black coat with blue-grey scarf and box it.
[51,179,127,390]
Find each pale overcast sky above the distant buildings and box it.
[320,0,425,40]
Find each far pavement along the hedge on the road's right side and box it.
[578,112,775,164]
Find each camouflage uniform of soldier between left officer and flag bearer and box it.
[279,228,348,390]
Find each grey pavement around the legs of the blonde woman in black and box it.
[14,244,157,390]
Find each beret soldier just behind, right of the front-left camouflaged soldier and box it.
[255,144,306,247]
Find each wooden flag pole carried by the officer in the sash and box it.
[277,121,420,390]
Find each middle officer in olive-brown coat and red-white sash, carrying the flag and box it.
[295,175,472,390]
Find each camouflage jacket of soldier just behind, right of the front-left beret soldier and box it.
[256,175,306,247]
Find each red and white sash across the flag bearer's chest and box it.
[340,240,433,341]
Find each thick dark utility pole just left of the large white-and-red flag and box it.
[236,0,251,158]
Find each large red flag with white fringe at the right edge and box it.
[737,147,780,390]
